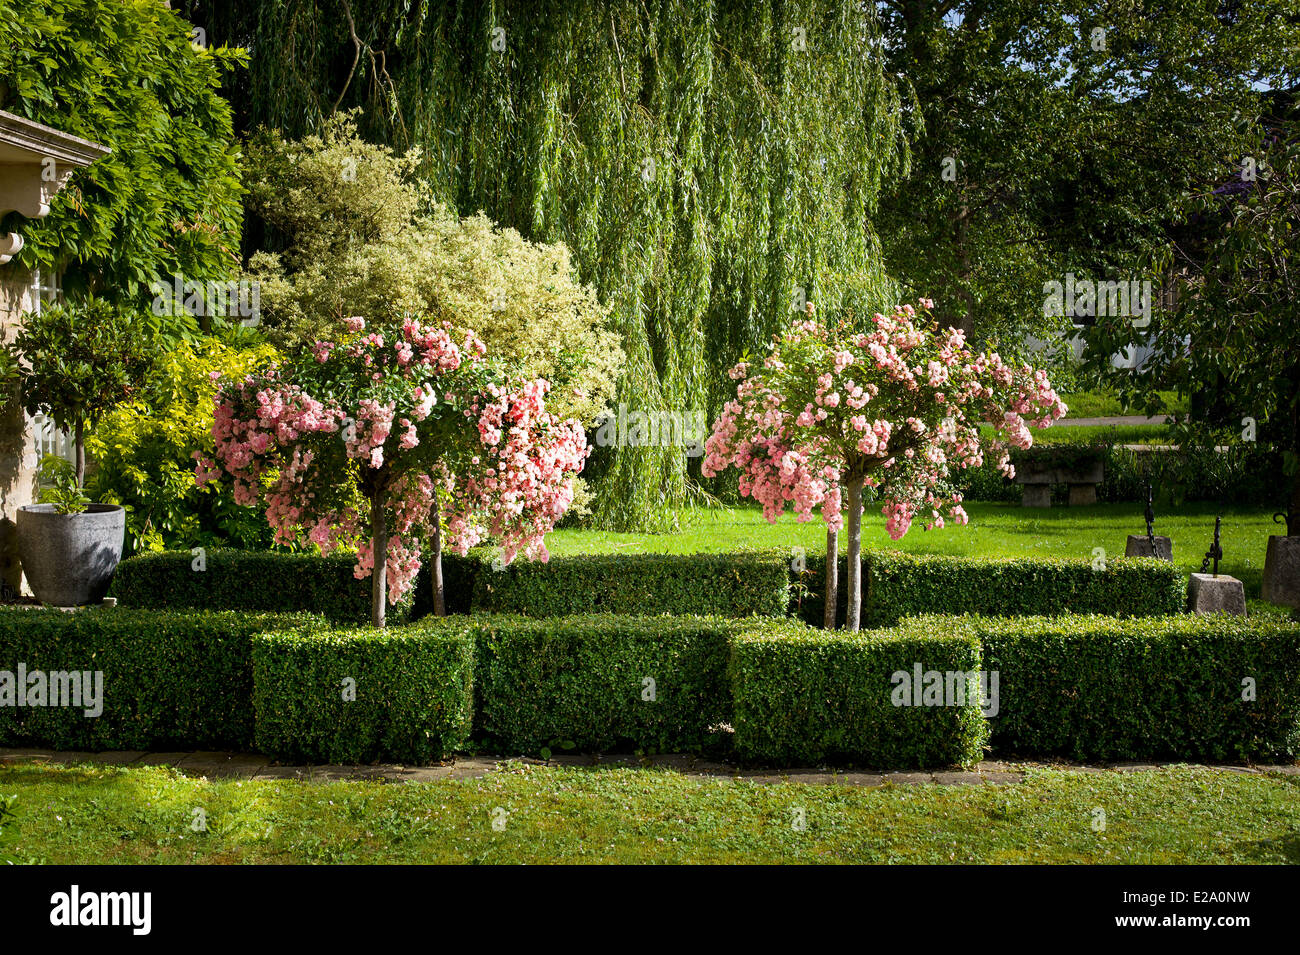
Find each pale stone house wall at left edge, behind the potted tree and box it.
[0,262,36,591]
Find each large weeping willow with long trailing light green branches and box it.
[189,0,907,530]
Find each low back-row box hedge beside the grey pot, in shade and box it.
[111,548,411,624]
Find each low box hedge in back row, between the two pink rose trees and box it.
[473,550,790,617]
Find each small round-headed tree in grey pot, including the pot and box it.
[9,298,150,607]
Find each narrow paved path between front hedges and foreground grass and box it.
[0,748,1300,786]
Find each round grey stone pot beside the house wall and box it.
[18,504,126,607]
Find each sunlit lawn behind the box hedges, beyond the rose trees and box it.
[546,503,1279,596]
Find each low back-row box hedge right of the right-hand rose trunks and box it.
[862,551,1187,626]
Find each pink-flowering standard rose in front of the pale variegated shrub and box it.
[195,317,588,626]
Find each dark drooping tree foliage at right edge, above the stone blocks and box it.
[1089,103,1300,535]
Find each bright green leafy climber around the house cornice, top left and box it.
[0,0,243,299]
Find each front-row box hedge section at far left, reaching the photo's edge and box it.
[0,608,314,750]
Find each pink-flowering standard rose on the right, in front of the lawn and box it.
[703,299,1066,630]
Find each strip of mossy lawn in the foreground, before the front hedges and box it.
[0,764,1300,865]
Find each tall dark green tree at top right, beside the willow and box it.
[878,0,1300,350]
